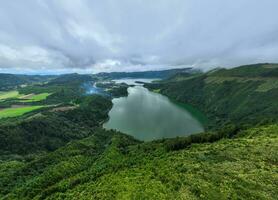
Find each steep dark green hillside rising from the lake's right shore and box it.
[147,64,278,127]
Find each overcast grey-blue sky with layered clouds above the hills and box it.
[0,0,278,74]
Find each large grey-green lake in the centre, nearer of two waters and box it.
[103,86,204,141]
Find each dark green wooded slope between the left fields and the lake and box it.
[0,96,112,155]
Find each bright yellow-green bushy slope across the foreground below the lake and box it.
[0,125,278,199]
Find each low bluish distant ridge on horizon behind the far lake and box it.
[94,68,192,79]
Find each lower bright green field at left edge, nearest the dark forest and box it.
[0,106,44,119]
